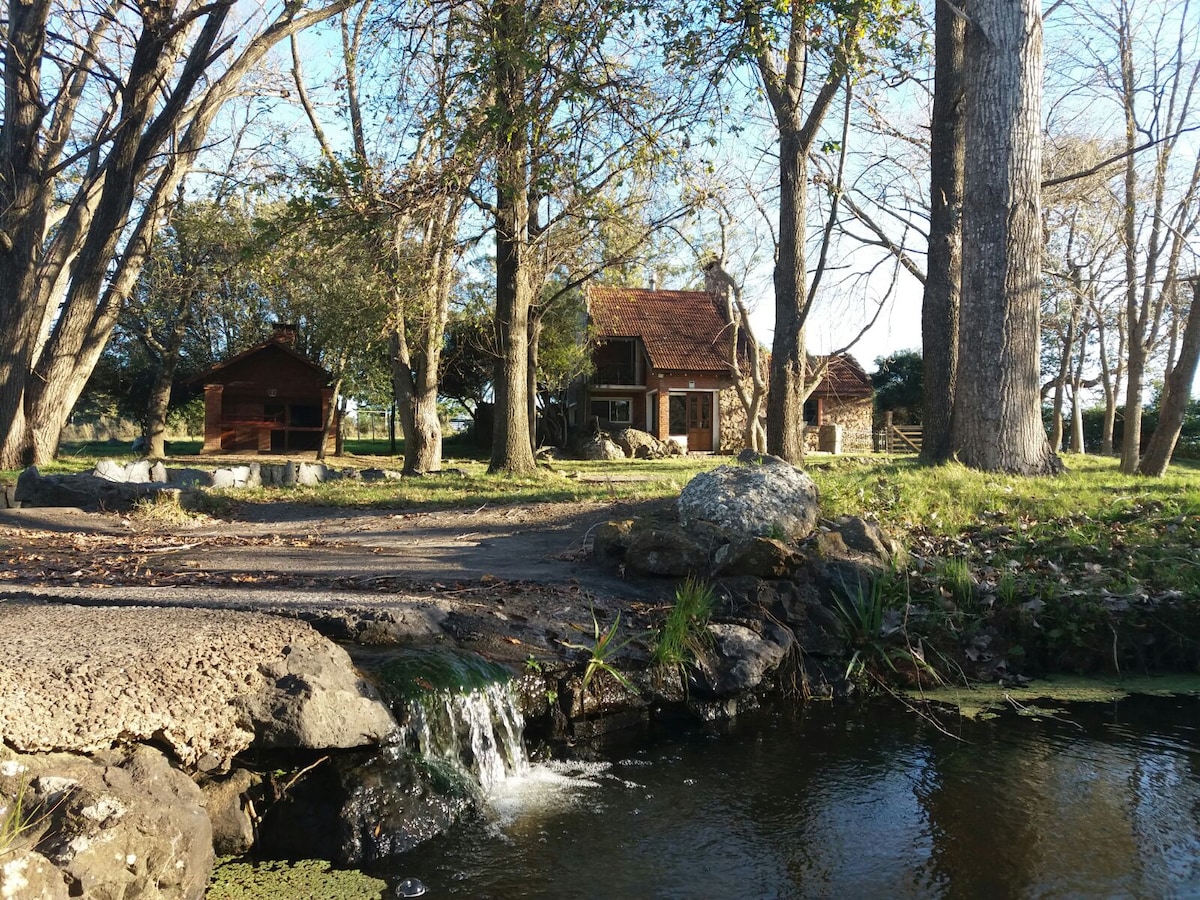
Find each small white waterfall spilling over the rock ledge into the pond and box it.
[406,682,529,797]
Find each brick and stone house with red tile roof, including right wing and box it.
[583,286,871,452]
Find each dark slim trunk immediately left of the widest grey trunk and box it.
[920,2,966,463]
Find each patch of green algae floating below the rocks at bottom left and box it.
[204,859,388,900]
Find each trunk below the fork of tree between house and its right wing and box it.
[767,127,808,463]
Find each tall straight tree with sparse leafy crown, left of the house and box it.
[470,0,686,474]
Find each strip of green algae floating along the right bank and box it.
[910,673,1200,719]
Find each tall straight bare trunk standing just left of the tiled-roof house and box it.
[487,0,536,475]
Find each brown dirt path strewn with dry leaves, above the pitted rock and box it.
[0,503,671,660]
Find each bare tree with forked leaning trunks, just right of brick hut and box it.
[292,0,479,474]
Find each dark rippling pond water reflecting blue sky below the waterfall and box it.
[390,698,1200,899]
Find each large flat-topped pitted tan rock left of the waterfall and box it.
[0,602,395,770]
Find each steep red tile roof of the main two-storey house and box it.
[588,286,730,374]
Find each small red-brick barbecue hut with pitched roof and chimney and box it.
[192,324,337,454]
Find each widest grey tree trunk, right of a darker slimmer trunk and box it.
[953,0,1061,474]
